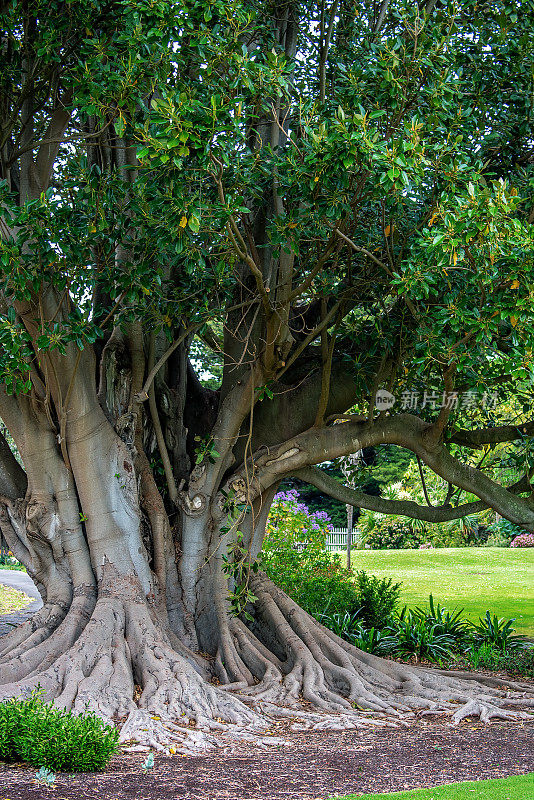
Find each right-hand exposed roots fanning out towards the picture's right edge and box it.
[213,576,534,727]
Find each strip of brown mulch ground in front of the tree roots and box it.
[0,720,534,800]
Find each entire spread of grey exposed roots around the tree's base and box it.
[0,577,534,753]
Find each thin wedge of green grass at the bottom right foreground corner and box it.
[330,772,534,800]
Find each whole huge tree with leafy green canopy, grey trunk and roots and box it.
[0,0,534,743]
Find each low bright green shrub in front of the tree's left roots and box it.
[0,694,119,772]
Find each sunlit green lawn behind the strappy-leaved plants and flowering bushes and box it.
[346,547,534,636]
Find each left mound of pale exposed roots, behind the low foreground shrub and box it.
[0,596,262,752]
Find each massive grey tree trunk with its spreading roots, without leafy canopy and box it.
[0,354,532,751]
